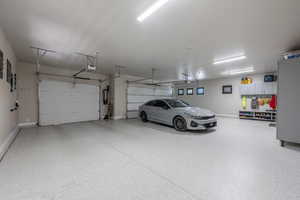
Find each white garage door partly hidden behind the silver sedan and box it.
[127,84,172,118]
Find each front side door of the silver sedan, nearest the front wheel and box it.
[153,100,173,124]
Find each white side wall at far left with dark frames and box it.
[0,28,18,158]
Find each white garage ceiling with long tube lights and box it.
[0,0,300,80]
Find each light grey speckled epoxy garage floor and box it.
[0,118,300,200]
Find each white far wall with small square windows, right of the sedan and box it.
[175,74,276,117]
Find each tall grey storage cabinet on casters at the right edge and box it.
[277,58,300,146]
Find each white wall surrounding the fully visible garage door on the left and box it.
[17,62,108,125]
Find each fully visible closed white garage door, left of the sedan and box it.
[39,80,99,126]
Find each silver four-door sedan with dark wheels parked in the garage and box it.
[139,99,217,131]
